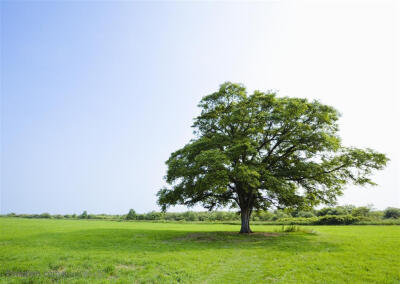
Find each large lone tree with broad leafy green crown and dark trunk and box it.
[158,82,388,233]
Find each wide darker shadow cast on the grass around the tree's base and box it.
[21,228,340,253]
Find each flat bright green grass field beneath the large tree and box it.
[0,218,400,283]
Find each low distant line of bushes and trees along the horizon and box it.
[3,205,400,225]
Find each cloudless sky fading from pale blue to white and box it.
[0,0,400,213]
